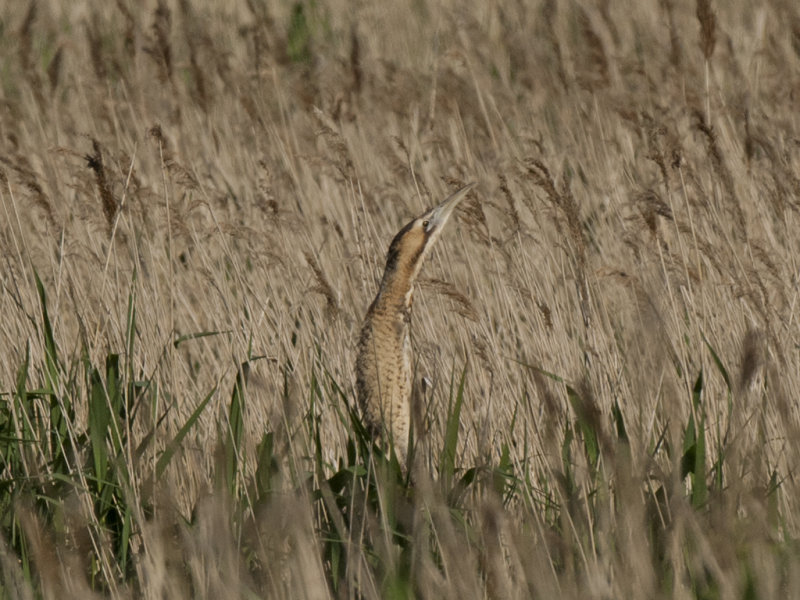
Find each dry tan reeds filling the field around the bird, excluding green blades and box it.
[0,0,800,598]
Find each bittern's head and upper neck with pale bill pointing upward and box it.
[381,183,475,304]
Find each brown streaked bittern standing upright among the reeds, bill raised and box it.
[356,183,475,466]
